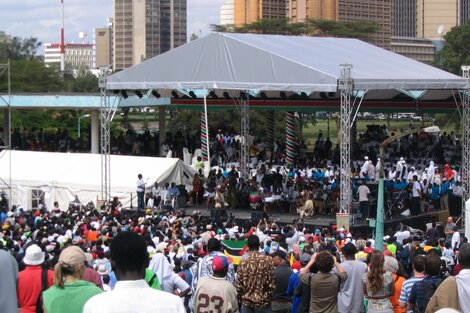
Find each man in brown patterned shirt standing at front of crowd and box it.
[236,235,275,313]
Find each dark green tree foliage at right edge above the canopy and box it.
[436,23,470,75]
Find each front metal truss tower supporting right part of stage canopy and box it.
[338,64,354,213]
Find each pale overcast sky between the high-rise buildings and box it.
[0,0,225,52]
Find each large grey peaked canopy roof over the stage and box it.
[105,33,468,93]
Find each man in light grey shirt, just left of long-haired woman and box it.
[338,243,368,313]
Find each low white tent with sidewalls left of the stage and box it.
[0,150,195,209]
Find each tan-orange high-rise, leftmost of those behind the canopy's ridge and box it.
[234,0,286,26]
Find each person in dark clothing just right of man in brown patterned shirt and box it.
[271,250,294,313]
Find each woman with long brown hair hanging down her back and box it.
[362,250,395,313]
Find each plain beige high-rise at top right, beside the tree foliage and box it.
[416,0,459,39]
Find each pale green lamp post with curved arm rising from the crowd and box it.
[375,126,441,251]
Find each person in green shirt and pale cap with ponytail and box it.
[43,246,102,313]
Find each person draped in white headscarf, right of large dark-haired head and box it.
[148,253,191,297]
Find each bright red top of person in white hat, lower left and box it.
[17,265,54,313]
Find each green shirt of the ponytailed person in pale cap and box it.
[43,280,102,313]
